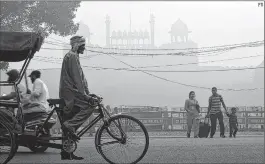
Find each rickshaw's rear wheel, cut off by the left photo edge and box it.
[0,121,15,164]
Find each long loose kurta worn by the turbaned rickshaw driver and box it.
[59,51,89,113]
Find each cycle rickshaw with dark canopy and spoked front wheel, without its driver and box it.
[0,32,149,164]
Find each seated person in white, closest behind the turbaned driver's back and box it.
[23,70,49,122]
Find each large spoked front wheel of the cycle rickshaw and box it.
[96,115,149,164]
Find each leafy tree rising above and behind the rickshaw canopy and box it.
[0,1,81,69]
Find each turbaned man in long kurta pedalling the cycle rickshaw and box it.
[59,36,93,160]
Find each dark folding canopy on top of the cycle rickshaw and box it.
[0,31,44,62]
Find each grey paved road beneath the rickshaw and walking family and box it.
[10,136,264,163]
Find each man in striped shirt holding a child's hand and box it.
[207,87,227,138]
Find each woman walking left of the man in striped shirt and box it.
[184,91,200,138]
